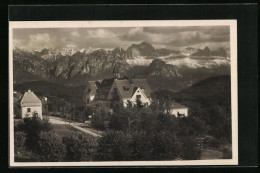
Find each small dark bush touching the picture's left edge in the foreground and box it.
[14,131,26,154]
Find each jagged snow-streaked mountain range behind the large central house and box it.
[13,42,230,91]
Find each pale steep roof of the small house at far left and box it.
[21,90,42,106]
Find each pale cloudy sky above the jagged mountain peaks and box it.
[13,26,230,50]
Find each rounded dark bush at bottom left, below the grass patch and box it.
[37,132,66,162]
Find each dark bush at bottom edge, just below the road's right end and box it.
[63,136,97,161]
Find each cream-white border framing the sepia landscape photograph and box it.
[9,20,238,167]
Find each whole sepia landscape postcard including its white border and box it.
[9,20,238,166]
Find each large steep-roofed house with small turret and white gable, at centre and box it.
[85,65,151,108]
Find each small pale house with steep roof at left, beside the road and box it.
[21,90,42,119]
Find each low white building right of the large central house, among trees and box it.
[164,101,189,117]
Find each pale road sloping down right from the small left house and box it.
[47,116,102,137]
